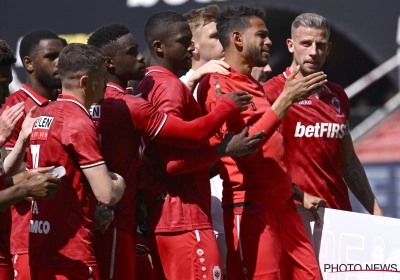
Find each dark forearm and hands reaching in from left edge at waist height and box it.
[0,167,61,211]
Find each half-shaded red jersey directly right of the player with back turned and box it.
[90,83,167,235]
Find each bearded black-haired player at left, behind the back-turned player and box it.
[0,29,63,280]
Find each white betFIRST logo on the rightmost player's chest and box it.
[294,122,347,139]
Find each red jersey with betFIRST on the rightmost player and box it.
[263,68,351,211]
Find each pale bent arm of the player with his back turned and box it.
[82,164,125,206]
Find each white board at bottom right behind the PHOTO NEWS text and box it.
[298,206,400,280]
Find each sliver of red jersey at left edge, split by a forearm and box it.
[0,150,11,266]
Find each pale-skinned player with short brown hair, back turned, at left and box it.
[29,44,125,280]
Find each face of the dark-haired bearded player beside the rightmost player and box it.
[243,17,272,67]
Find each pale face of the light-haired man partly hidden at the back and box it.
[194,22,224,62]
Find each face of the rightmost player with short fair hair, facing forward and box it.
[286,26,332,76]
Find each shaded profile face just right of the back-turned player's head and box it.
[113,33,146,81]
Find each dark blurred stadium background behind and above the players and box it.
[0,0,400,217]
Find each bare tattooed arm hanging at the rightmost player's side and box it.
[342,133,383,216]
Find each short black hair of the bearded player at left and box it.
[19,29,60,61]
